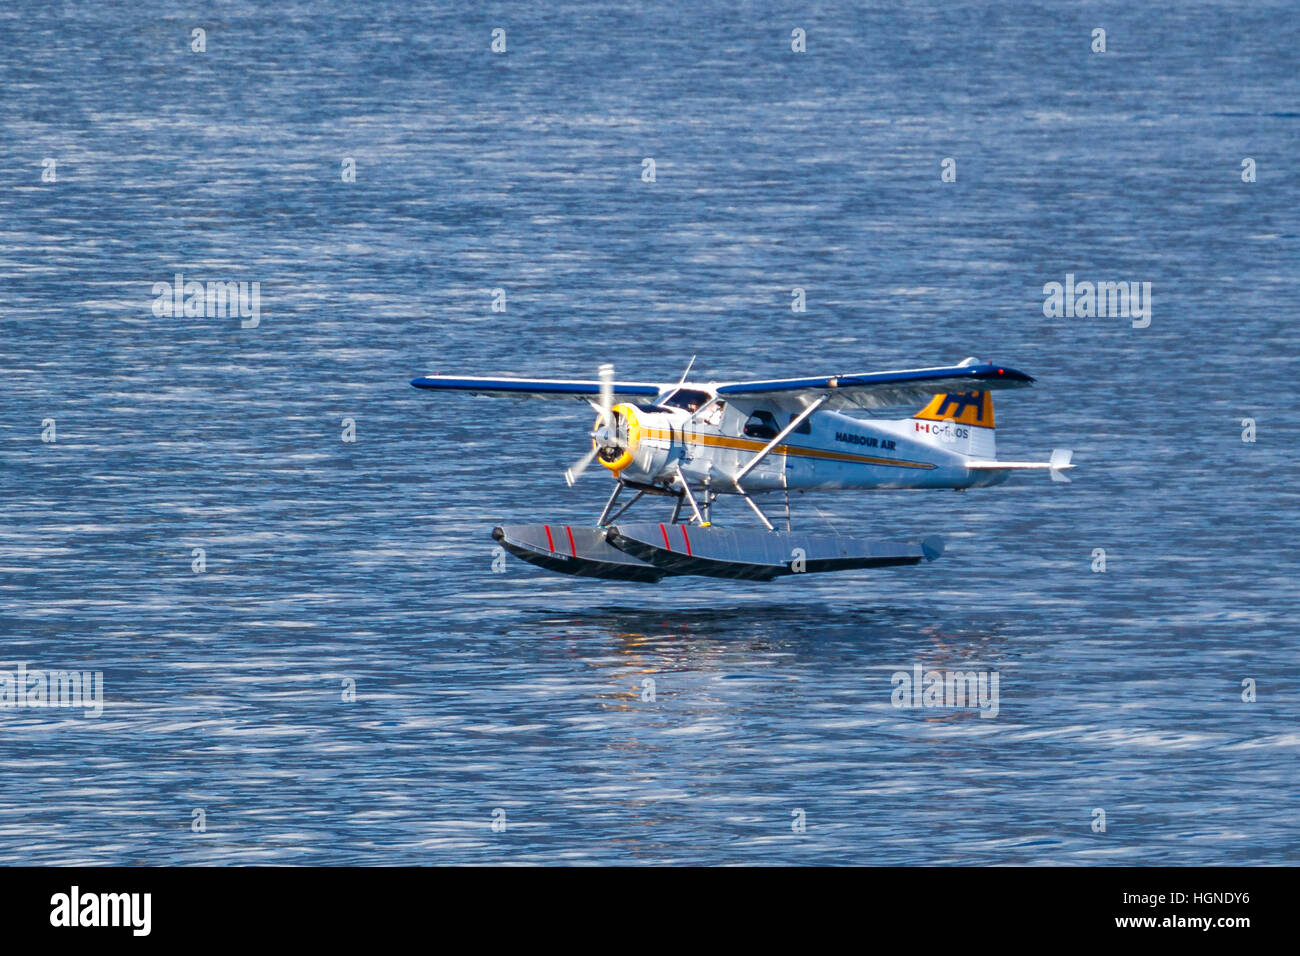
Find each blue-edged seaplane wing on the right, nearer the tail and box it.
[718,359,1034,408]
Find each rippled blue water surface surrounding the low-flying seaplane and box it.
[0,0,1300,864]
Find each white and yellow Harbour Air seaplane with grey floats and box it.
[411,358,1074,581]
